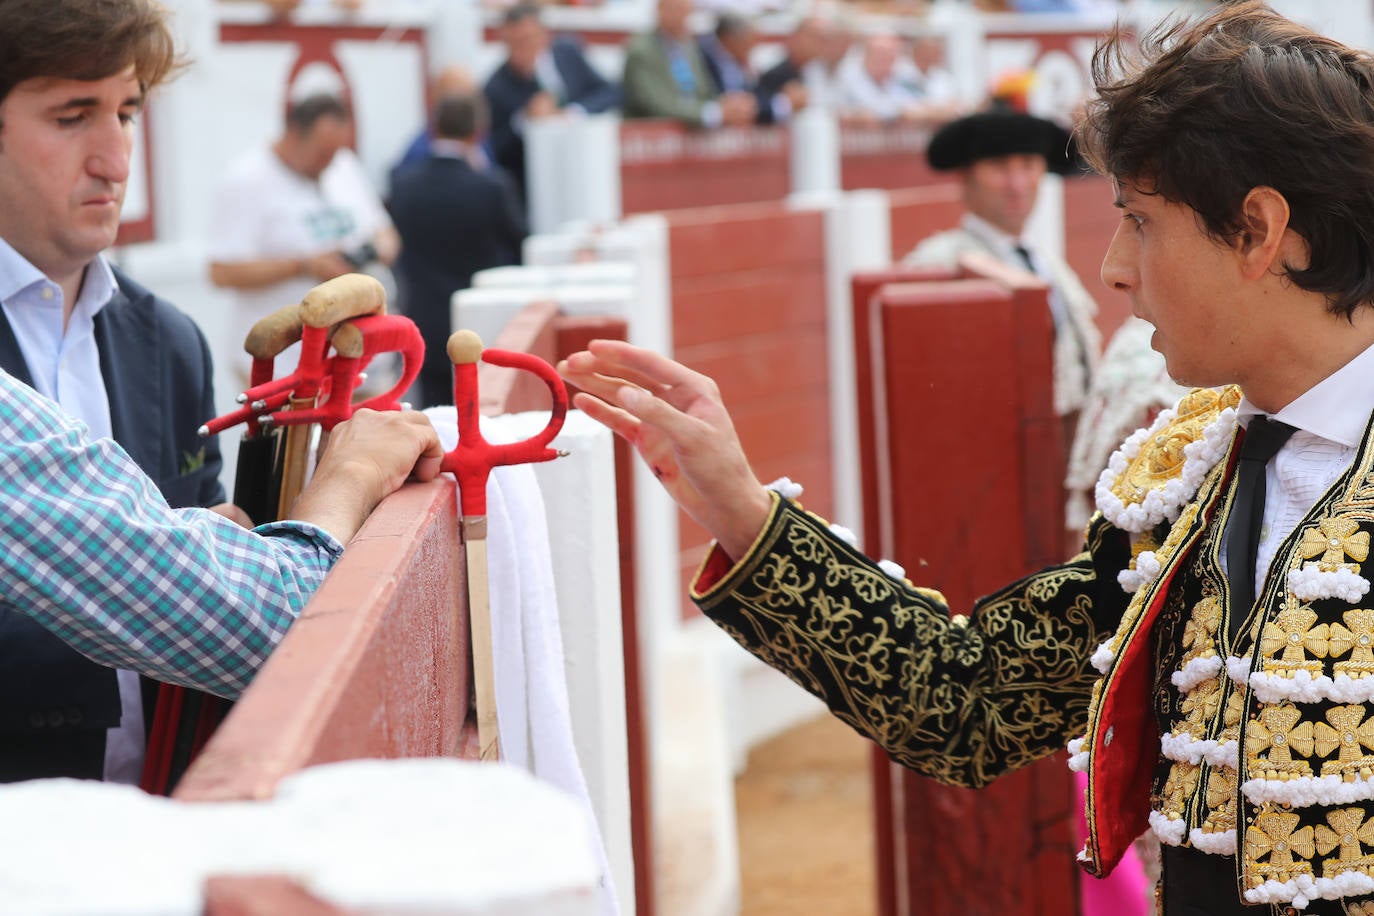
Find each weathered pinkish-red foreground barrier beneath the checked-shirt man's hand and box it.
[174,477,469,801]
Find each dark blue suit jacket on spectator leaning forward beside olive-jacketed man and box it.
[482,37,620,195]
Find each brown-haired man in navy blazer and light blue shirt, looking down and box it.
[0,0,232,783]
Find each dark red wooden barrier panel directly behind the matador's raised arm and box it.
[855,279,1077,916]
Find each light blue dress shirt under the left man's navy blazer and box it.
[0,239,144,784]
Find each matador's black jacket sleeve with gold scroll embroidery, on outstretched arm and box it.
[694,500,1129,787]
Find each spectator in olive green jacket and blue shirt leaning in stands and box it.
[621,0,758,128]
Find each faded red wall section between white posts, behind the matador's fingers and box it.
[666,203,833,615]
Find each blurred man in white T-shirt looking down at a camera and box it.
[210,95,400,372]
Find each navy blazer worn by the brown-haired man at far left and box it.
[0,271,225,781]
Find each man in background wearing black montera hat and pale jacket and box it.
[905,110,1101,425]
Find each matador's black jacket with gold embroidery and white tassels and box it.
[692,389,1374,916]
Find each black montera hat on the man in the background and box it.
[926,108,1076,174]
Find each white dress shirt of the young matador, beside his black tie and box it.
[1221,340,1374,595]
